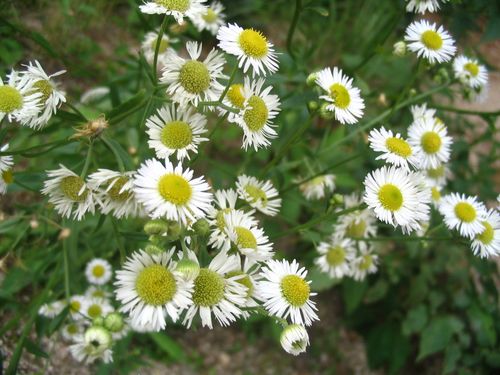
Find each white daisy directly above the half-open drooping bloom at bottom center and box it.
[257,260,319,326]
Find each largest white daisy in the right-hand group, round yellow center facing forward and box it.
[363,166,430,233]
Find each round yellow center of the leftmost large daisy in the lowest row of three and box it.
[135,264,177,306]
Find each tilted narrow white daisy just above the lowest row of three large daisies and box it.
[224,210,274,262]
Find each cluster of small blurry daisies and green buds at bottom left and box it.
[38,258,129,364]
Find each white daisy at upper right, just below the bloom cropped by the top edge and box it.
[405,20,457,64]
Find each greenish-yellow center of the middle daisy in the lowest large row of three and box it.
[193,268,226,307]
